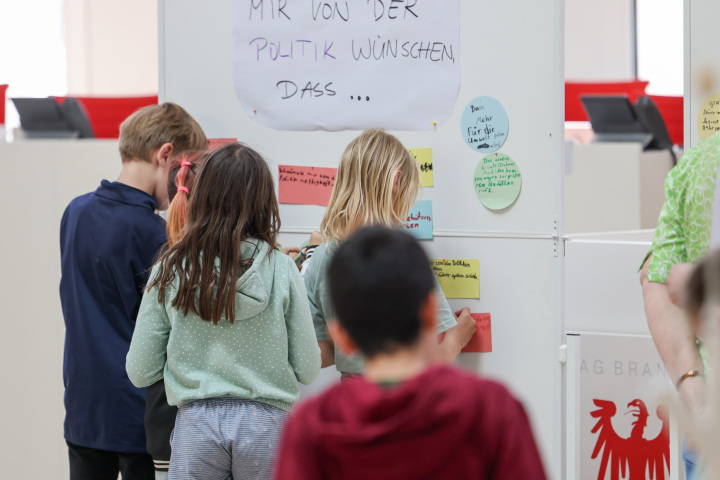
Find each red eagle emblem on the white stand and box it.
[590,398,670,480]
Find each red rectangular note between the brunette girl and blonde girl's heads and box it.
[278,165,337,207]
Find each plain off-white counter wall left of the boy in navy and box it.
[0,140,121,479]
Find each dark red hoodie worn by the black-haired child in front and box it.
[278,367,544,480]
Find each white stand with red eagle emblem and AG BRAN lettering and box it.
[565,230,683,480]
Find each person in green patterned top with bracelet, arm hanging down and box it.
[640,133,720,480]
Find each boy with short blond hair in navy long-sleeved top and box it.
[60,103,207,480]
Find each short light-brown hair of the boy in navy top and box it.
[118,103,208,162]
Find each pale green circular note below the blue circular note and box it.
[473,152,522,210]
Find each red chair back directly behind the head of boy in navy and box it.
[54,95,158,138]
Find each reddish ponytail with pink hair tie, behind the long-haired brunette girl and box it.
[166,150,205,247]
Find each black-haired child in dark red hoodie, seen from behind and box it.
[275,227,545,480]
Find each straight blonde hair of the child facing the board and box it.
[320,129,420,242]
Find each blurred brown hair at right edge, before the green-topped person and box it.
[684,249,720,328]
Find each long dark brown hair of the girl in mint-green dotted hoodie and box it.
[148,143,280,324]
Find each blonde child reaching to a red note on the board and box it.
[304,129,475,377]
